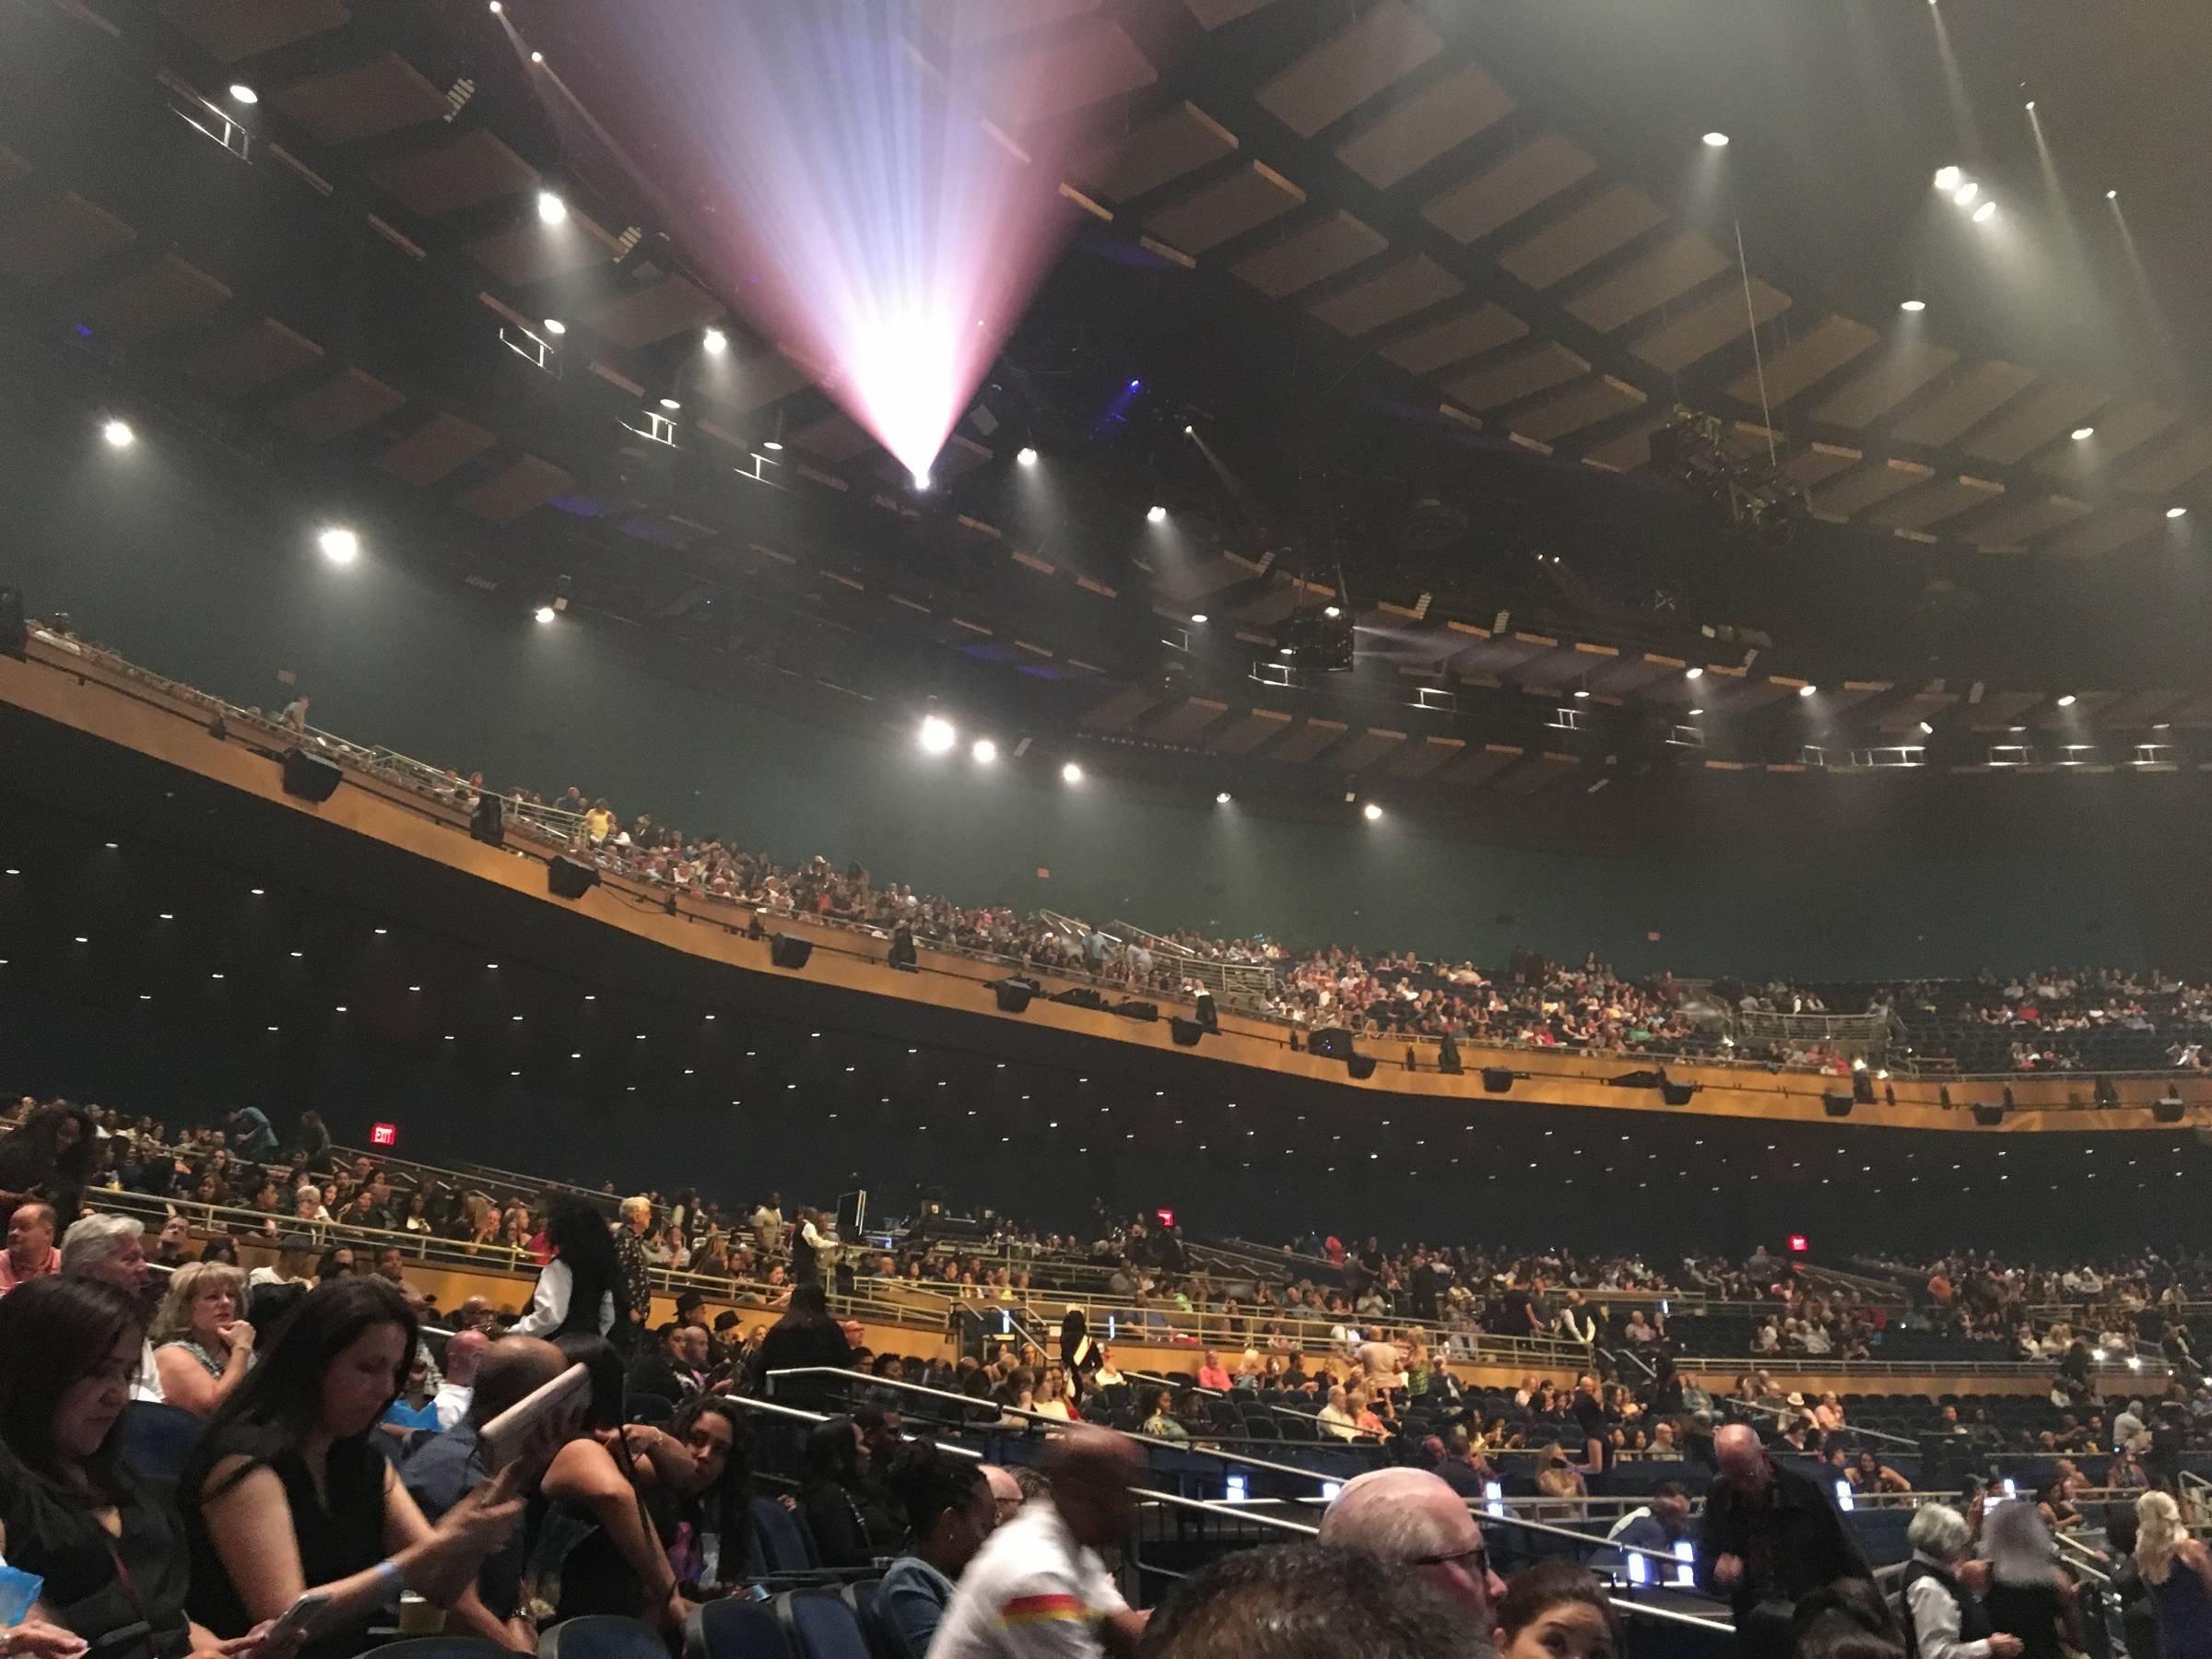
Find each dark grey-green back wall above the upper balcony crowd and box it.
[0,387,2212,978]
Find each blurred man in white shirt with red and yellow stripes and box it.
[929,1427,1144,1659]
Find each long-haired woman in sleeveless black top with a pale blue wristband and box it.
[177,1277,522,1659]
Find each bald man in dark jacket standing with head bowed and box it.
[1697,1422,1880,1659]
